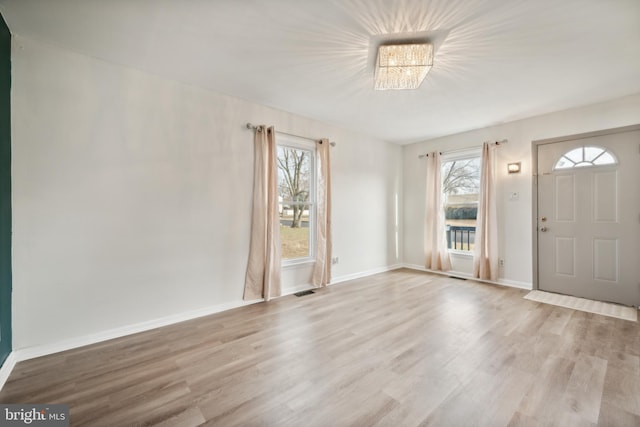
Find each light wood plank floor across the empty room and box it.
[0,270,640,427]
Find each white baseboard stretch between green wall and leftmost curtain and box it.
[12,299,263,368]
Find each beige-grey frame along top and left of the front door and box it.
[531,124,640,290]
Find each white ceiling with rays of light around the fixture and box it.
[0,0,640,144]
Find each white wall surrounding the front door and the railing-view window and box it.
[403,94,640,287]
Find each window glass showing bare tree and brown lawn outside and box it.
[277,137,316,264]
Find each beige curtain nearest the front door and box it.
[473,142,498,281]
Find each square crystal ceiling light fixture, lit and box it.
[374,43,433,90]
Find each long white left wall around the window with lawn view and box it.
[12,37,402,350]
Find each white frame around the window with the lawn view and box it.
[276,135,318,267]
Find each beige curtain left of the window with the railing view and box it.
[424,152,451,271]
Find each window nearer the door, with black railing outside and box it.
[442,150,481,252]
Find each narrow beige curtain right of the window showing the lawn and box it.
[312,139,331,287]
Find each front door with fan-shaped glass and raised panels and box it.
[537,130,640,306]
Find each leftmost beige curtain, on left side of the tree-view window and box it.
[243,126,281,301]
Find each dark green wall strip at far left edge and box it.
[0,15,11,365]
